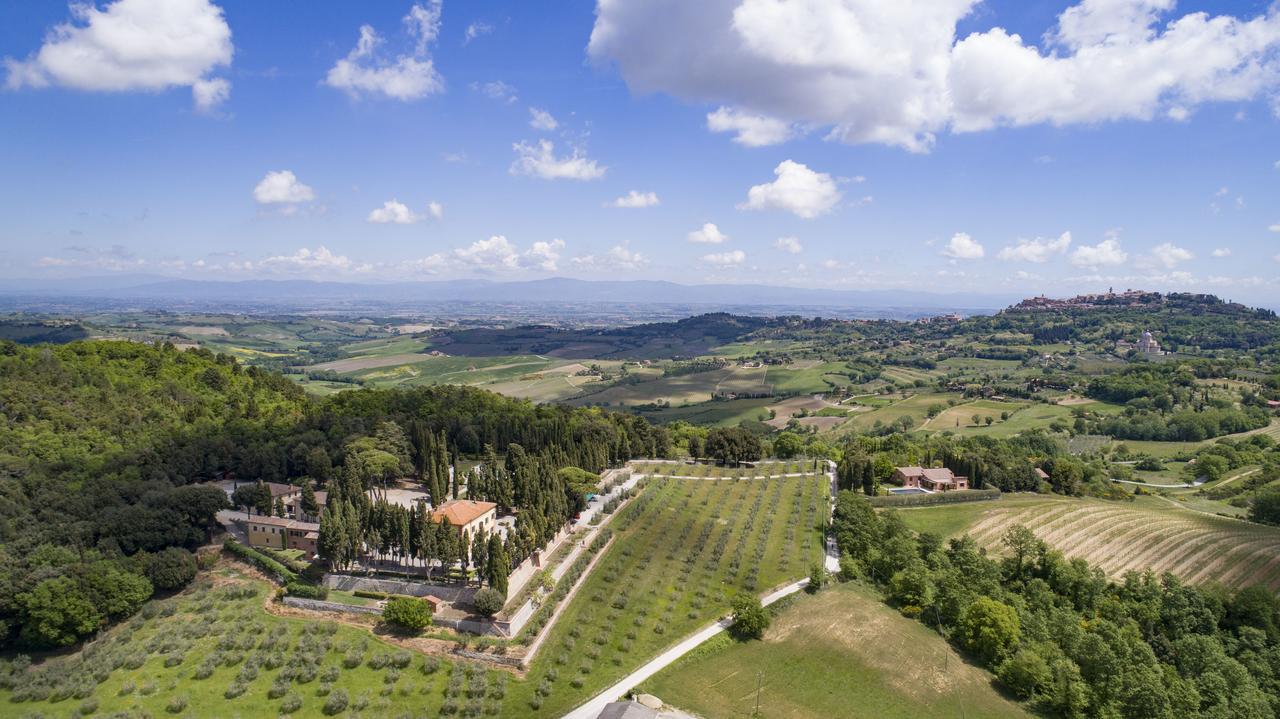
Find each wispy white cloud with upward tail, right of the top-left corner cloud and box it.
[324,0,444,101]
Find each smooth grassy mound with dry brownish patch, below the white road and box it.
[644,585,1029,719]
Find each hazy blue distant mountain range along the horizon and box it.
[0,275,1021,312]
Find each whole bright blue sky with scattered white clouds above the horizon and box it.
[0,0,1280,302]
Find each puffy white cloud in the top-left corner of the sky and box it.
[4,0,234,110]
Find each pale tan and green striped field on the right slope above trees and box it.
[906,498,1280,590]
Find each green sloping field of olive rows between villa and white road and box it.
[512,476,828,716]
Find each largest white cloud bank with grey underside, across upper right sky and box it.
[588,0,1280,151]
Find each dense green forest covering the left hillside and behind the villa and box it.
[0,342,668,647]
